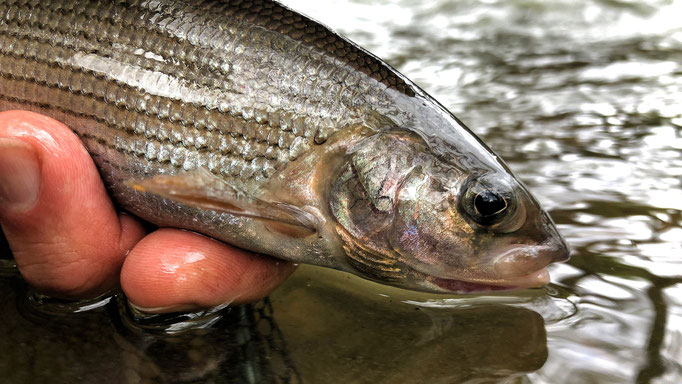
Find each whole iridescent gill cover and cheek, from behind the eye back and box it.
[330,131,472,282]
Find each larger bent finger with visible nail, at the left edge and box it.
[0,111,144,298]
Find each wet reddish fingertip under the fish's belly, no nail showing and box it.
[121,229,295,312]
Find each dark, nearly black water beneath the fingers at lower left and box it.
[0,279,301,384]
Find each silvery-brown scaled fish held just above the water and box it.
[0,0,569,293]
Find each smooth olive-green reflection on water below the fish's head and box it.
[272,268,547,383]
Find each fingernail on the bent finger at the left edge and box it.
[0,139,40,211]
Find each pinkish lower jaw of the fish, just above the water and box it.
[428,268,549,293]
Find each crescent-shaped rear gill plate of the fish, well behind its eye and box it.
[329,132,428,282]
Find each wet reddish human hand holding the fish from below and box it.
[0,111,295,312]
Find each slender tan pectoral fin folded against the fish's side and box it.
[125,168,317,234]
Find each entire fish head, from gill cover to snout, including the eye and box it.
[330,133,569,293]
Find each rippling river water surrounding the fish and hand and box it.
[0,0,682,383]
